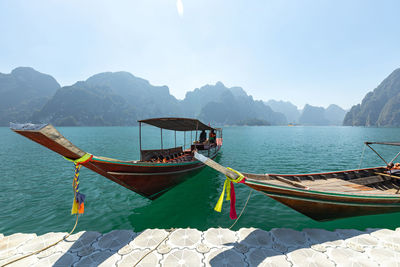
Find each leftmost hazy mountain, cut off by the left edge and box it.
[0,67,60,126]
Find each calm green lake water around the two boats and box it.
[0,126,400,234]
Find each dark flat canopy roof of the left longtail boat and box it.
[138,118,218,131]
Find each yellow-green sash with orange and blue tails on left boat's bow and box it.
[64,153,93,214]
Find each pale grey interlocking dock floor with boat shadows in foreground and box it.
[0,228,400,267]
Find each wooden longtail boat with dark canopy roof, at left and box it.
[11,118,222,199]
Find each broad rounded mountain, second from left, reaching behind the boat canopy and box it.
[33,72,182,126]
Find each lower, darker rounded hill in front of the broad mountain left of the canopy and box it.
[32,82,137,126]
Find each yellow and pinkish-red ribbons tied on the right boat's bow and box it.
[214,168,246,220]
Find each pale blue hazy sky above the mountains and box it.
[0,0,400,108]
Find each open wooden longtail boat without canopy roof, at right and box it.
[195,142,400,221]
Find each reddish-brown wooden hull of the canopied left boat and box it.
[12,124,222,200]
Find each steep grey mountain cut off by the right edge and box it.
[343,69,400,127]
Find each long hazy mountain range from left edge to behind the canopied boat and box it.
[0,67,287,126]
